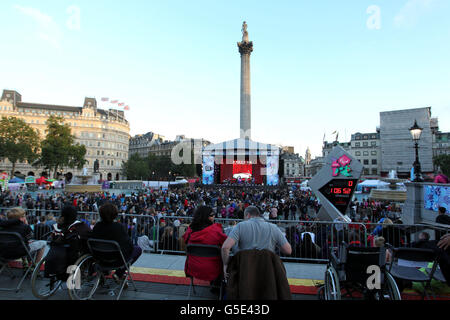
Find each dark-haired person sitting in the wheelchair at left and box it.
[45,205,91,280]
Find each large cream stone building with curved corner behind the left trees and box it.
[0,90,130,180]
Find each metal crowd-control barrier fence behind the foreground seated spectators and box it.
[0,208,450,263]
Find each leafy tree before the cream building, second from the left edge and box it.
[35,116,86,177]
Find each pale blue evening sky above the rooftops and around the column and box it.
[0,0,450,156]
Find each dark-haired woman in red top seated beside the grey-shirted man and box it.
[183,206,227,281]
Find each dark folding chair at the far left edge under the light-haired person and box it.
[0,231,36,292]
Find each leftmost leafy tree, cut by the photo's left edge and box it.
[0,117,39,177]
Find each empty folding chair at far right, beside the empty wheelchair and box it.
[389,248,438,299]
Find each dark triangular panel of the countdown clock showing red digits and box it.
[319,179,358,215]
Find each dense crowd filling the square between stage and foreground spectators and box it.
[0,186,444,259]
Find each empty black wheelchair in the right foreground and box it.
[318,242,401,300]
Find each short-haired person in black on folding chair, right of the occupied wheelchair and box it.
[91,202,142,282]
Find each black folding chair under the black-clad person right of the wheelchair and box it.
[87,239,137,300]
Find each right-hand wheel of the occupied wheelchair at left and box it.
[68,254,101,300]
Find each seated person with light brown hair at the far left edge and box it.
[0,208,47,263]
